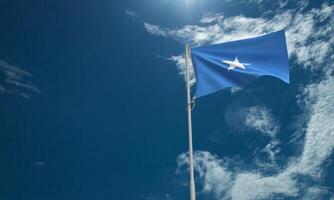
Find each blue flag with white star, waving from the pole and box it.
[191,30,289,98]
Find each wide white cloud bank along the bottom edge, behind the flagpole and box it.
[177,151,331,200]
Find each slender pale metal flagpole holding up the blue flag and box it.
[185,45,196,200]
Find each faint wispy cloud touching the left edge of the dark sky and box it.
[0,60,39,98]
